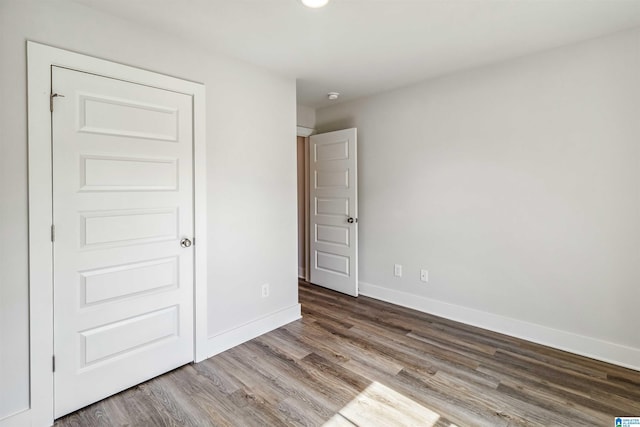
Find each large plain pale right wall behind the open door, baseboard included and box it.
[316,30,640,369]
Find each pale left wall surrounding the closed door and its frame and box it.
[0,0,298,419]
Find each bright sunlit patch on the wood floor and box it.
[324,382,440,427]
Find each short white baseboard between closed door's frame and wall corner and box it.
[207,304,302,357]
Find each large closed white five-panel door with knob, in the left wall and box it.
[52,67,194,417]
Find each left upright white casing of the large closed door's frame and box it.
[27,42,53,426]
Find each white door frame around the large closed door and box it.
[27,42,207,426]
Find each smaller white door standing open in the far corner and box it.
[309,128,358,296]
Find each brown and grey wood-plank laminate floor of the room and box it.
[55,282,640,427]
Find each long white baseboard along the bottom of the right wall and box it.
[360,282,640,371]
